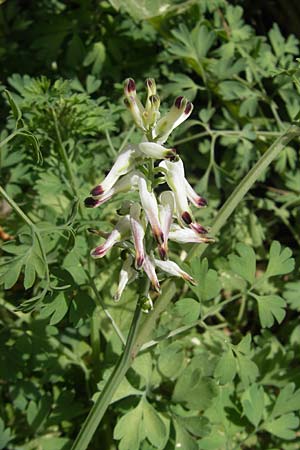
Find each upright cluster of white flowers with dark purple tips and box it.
[85,78,213,306]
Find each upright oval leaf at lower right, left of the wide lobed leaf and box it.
[242,384,264,428]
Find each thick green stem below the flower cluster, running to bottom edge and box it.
[72,301,142,450]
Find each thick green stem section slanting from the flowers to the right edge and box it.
[187,125,300,259]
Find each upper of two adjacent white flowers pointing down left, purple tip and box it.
[91,145,139,198]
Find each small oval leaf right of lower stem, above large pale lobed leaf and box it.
[158,342,184,379]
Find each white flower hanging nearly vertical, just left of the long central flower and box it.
[130,203,145,269]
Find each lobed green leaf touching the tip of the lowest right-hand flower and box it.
[191,258,222,302]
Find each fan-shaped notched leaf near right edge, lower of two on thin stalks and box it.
[253,294,286,328]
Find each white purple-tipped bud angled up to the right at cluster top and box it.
[154,97,193,144]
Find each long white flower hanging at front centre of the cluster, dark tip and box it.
[138,175,164,244]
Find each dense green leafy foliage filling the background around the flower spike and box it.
[0,0,300,450]
